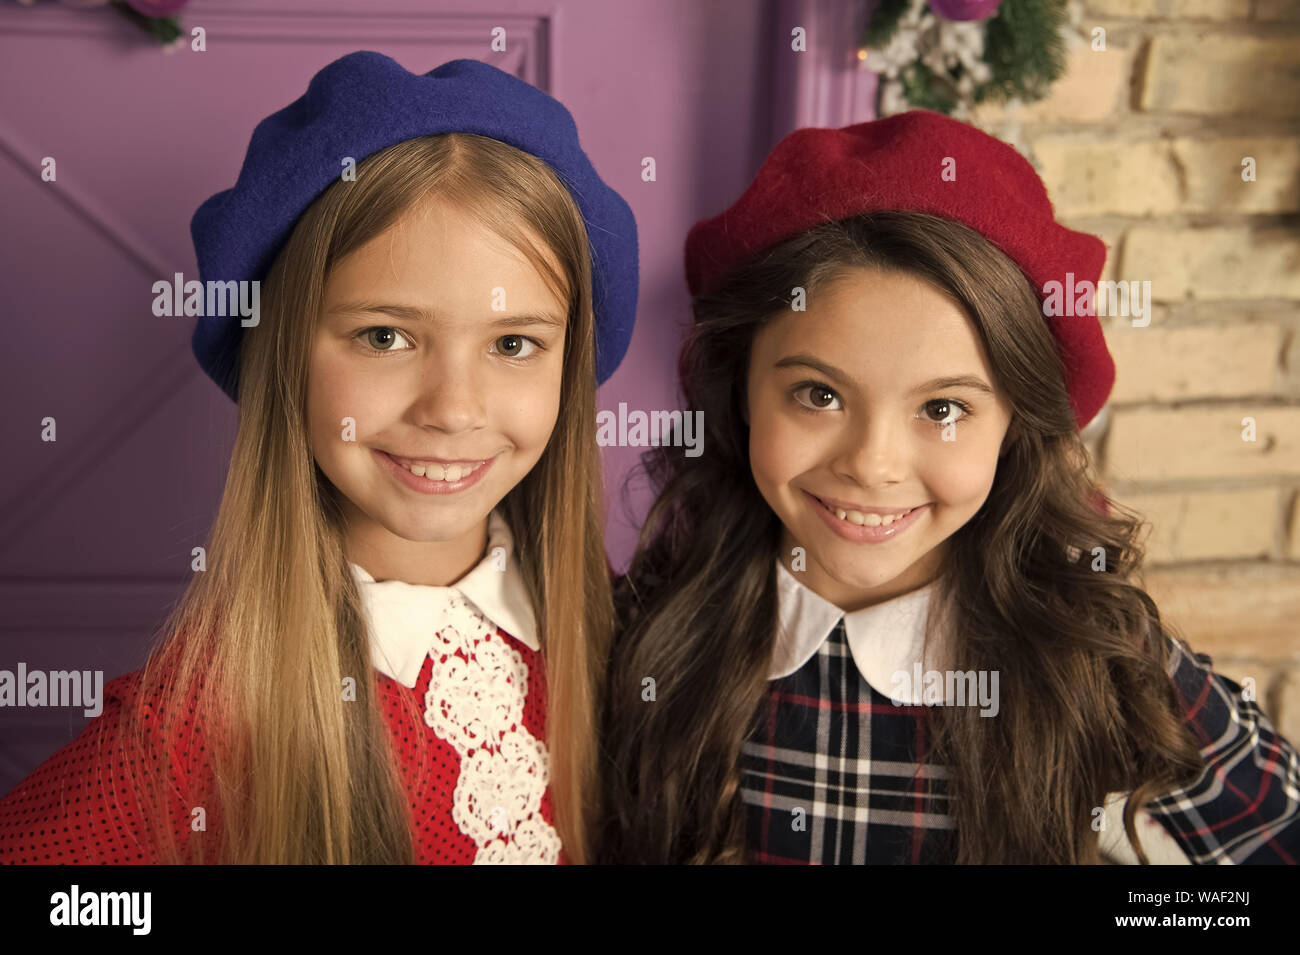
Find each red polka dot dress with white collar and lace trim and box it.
[0,512,566,864]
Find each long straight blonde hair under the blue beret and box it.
[120,134,612,864]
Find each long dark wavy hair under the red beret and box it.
[599,212,1204,864]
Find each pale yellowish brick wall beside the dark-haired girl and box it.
[975,0,1300,741]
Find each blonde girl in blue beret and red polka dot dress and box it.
[0,52,637,864]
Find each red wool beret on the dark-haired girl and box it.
[686,109,1115,429]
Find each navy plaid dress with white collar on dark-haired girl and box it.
[741,561,1300,864]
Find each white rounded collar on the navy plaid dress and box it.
[767,557,943,703]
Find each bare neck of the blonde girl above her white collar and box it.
[343,515,488,587]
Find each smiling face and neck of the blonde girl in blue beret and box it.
[308,200,568,583]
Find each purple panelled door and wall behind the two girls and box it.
[0,0,874,794]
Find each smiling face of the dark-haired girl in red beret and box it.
[746,268,1011,611]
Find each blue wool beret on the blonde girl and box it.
[190,51,637,400]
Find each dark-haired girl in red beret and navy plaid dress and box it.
[601,112,1300,863]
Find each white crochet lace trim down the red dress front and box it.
[424,592,560,865]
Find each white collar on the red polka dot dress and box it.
[348,511,540,687]
